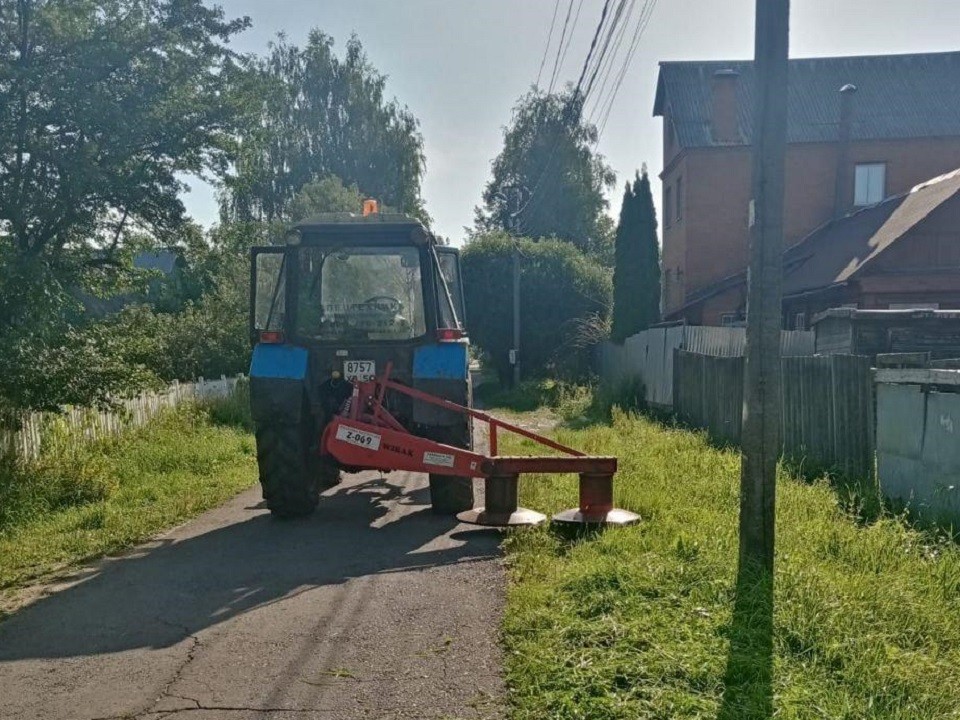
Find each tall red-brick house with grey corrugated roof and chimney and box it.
[654,52,960,325]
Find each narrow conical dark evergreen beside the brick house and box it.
[610,168,660,343]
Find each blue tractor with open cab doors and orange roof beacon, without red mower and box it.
[250,212,473,516]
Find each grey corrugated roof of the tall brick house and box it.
[653,52,960,148]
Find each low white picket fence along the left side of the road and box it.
[0,375,243,460]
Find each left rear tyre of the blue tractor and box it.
[257,422,320,519]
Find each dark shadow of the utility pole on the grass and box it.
[717,565,773,720]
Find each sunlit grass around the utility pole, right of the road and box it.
[504,411,960,720]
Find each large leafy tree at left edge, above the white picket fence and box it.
[0,0,248,407]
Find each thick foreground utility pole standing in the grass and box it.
[740,0,790,577]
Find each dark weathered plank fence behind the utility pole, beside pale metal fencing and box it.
[673,350,874,478]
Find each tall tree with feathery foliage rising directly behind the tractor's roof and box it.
[223,30,426,221]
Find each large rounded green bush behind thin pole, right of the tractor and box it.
[463,233,612,382]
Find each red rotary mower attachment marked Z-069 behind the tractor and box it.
[321,363,640,526]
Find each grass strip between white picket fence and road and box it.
[0,399,256,592]
